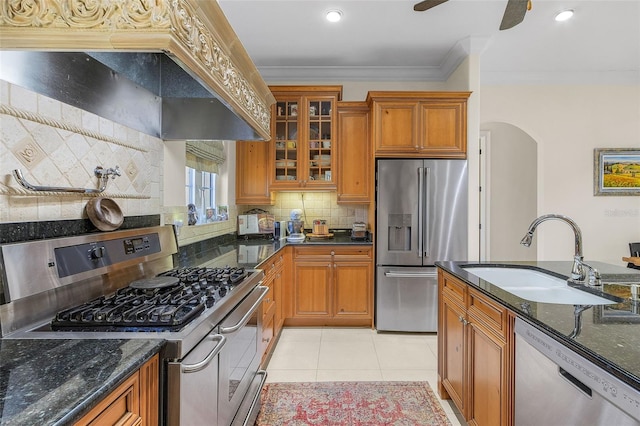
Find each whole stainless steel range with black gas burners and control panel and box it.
[0,226,268,426]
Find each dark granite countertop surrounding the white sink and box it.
[436,261,640,391]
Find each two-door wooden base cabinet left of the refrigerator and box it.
[285,245,373,326]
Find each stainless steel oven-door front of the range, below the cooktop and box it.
[167,286,269,425]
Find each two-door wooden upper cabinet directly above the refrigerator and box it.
[367,92,471,158]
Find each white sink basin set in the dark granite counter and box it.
[462,265,618,305]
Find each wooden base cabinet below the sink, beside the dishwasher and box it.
[438,270,515,426]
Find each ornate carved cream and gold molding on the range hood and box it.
[0,0,275,140]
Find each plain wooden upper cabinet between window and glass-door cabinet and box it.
[236,141,275,205]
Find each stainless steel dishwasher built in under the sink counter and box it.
[515,318,640,426]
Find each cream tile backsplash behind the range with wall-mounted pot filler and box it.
[0,81,163,222]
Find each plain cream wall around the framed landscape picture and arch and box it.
[480,86,640,266]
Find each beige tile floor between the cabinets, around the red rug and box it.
[267,327,466,426]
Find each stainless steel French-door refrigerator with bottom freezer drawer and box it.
[375,159,468,332]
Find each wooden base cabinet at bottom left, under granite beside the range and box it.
[75,355,160,426]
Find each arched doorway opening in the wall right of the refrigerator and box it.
[480,123,538,261]
